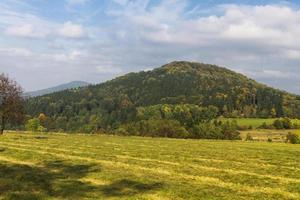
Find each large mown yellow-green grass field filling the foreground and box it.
[0,133,300,200]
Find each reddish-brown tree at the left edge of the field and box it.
[0,74,24,135]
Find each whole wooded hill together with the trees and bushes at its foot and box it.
[1,62,300,139]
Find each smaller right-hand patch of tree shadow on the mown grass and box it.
[102,179,163,197]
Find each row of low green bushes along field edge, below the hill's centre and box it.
[114,119,240,140]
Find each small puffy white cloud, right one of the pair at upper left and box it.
[58,21,86,39]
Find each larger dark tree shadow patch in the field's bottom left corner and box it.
[0,161,100,200]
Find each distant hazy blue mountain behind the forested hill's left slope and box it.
[25,81,90,97]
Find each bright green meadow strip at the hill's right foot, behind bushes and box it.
[221,118,300,128]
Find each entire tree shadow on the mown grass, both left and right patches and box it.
[0,160,163,200]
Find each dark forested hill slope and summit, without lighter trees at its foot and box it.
[26,61,300,133]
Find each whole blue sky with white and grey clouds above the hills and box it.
[0,0,300,94]
